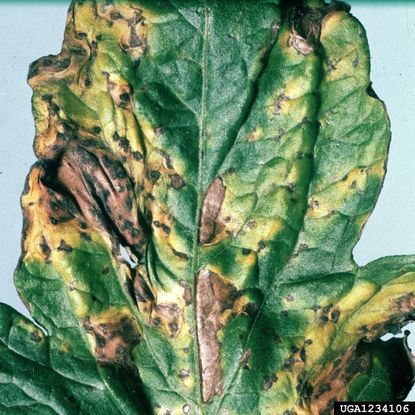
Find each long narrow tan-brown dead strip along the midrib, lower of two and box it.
[196,269,237,402]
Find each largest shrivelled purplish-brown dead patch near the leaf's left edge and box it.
[43,144,144,247]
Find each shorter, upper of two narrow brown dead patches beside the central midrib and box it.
[199,177,226,245]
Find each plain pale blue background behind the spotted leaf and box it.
[0,1,415,400]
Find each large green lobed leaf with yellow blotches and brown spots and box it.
[0,0,415,415]
